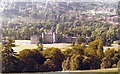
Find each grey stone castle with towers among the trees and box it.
[30,31,76,44]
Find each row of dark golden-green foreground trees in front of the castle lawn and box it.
[2,38,120,73]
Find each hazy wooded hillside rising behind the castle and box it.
[2,2,120,45]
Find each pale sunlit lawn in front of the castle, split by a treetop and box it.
[13,40,71,52]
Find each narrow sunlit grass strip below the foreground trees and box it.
[33,68,120,74]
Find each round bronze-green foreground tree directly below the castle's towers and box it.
[43,48,64,71]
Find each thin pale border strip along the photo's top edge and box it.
[0,0,120,2]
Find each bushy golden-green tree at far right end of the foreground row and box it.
[101,48,120,68]
